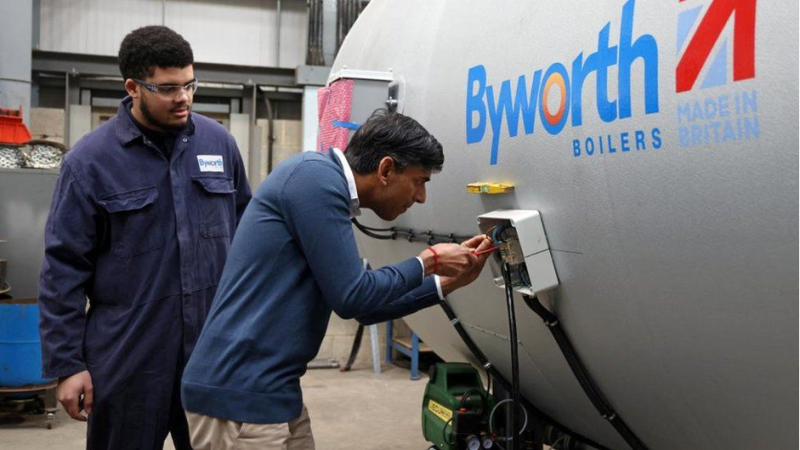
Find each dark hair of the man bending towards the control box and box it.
[344,110,444,175]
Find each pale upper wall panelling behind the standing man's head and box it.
[40,0,308,67]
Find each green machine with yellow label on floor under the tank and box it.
[422,363,495,450]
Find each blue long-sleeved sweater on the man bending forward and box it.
[181,152,439,424]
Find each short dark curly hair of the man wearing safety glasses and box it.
[119,25,194,80]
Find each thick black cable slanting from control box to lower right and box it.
[522,294,647,450]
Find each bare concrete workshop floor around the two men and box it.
[0,366,428,450]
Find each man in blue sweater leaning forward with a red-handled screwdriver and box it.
[181,113,491,450]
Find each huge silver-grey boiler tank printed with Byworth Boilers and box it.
[333,0,800,450]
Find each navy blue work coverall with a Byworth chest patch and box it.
[39,98,250,450]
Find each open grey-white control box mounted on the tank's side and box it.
[478,209,559,295]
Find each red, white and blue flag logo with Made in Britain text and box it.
[675,0,760,147]
